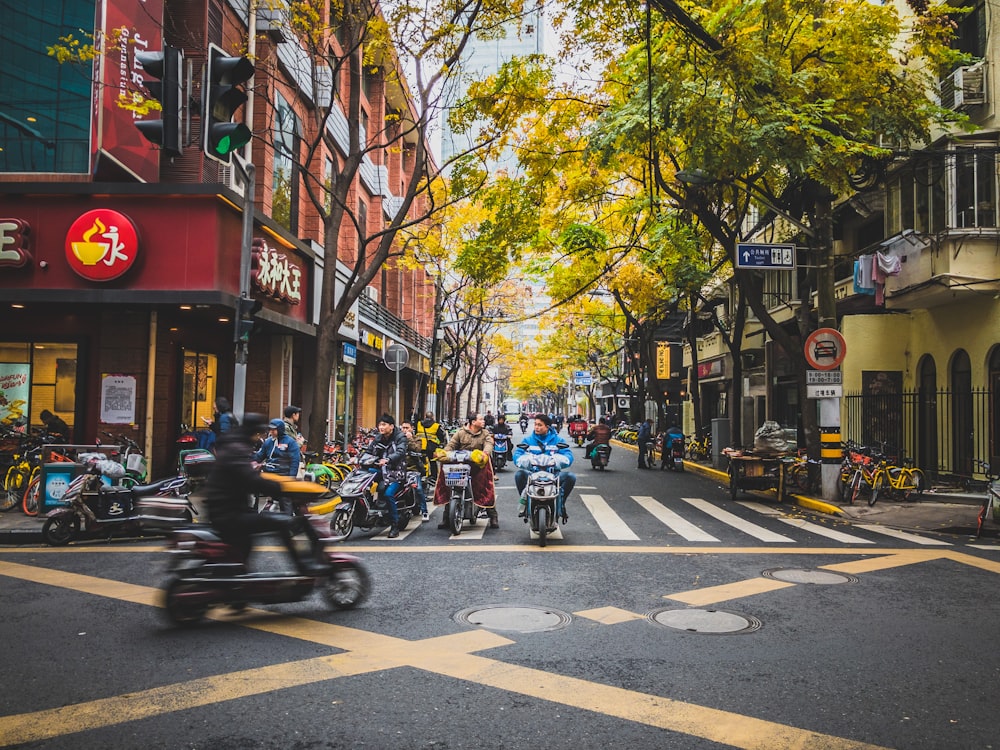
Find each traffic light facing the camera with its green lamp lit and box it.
[201,44,254,164]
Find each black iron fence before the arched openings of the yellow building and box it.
[841,388,1000,479]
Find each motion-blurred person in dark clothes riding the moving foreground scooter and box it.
[203,414,329,575]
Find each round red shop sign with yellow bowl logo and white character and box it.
[66,208,139,281]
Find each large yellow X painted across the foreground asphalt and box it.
[0,564,896,750]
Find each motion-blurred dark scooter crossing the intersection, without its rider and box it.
[163,477,370,626]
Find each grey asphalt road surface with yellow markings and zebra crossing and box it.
[0,451,1000,750]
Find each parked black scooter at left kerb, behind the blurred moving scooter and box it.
[42,462,196,547]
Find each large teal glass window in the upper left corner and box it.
[0,0,94,173]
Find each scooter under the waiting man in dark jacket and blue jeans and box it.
[330,453,423,540]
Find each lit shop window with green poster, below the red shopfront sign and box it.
[0,342,77,438]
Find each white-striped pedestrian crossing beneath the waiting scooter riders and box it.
[356,488,1000,552]
